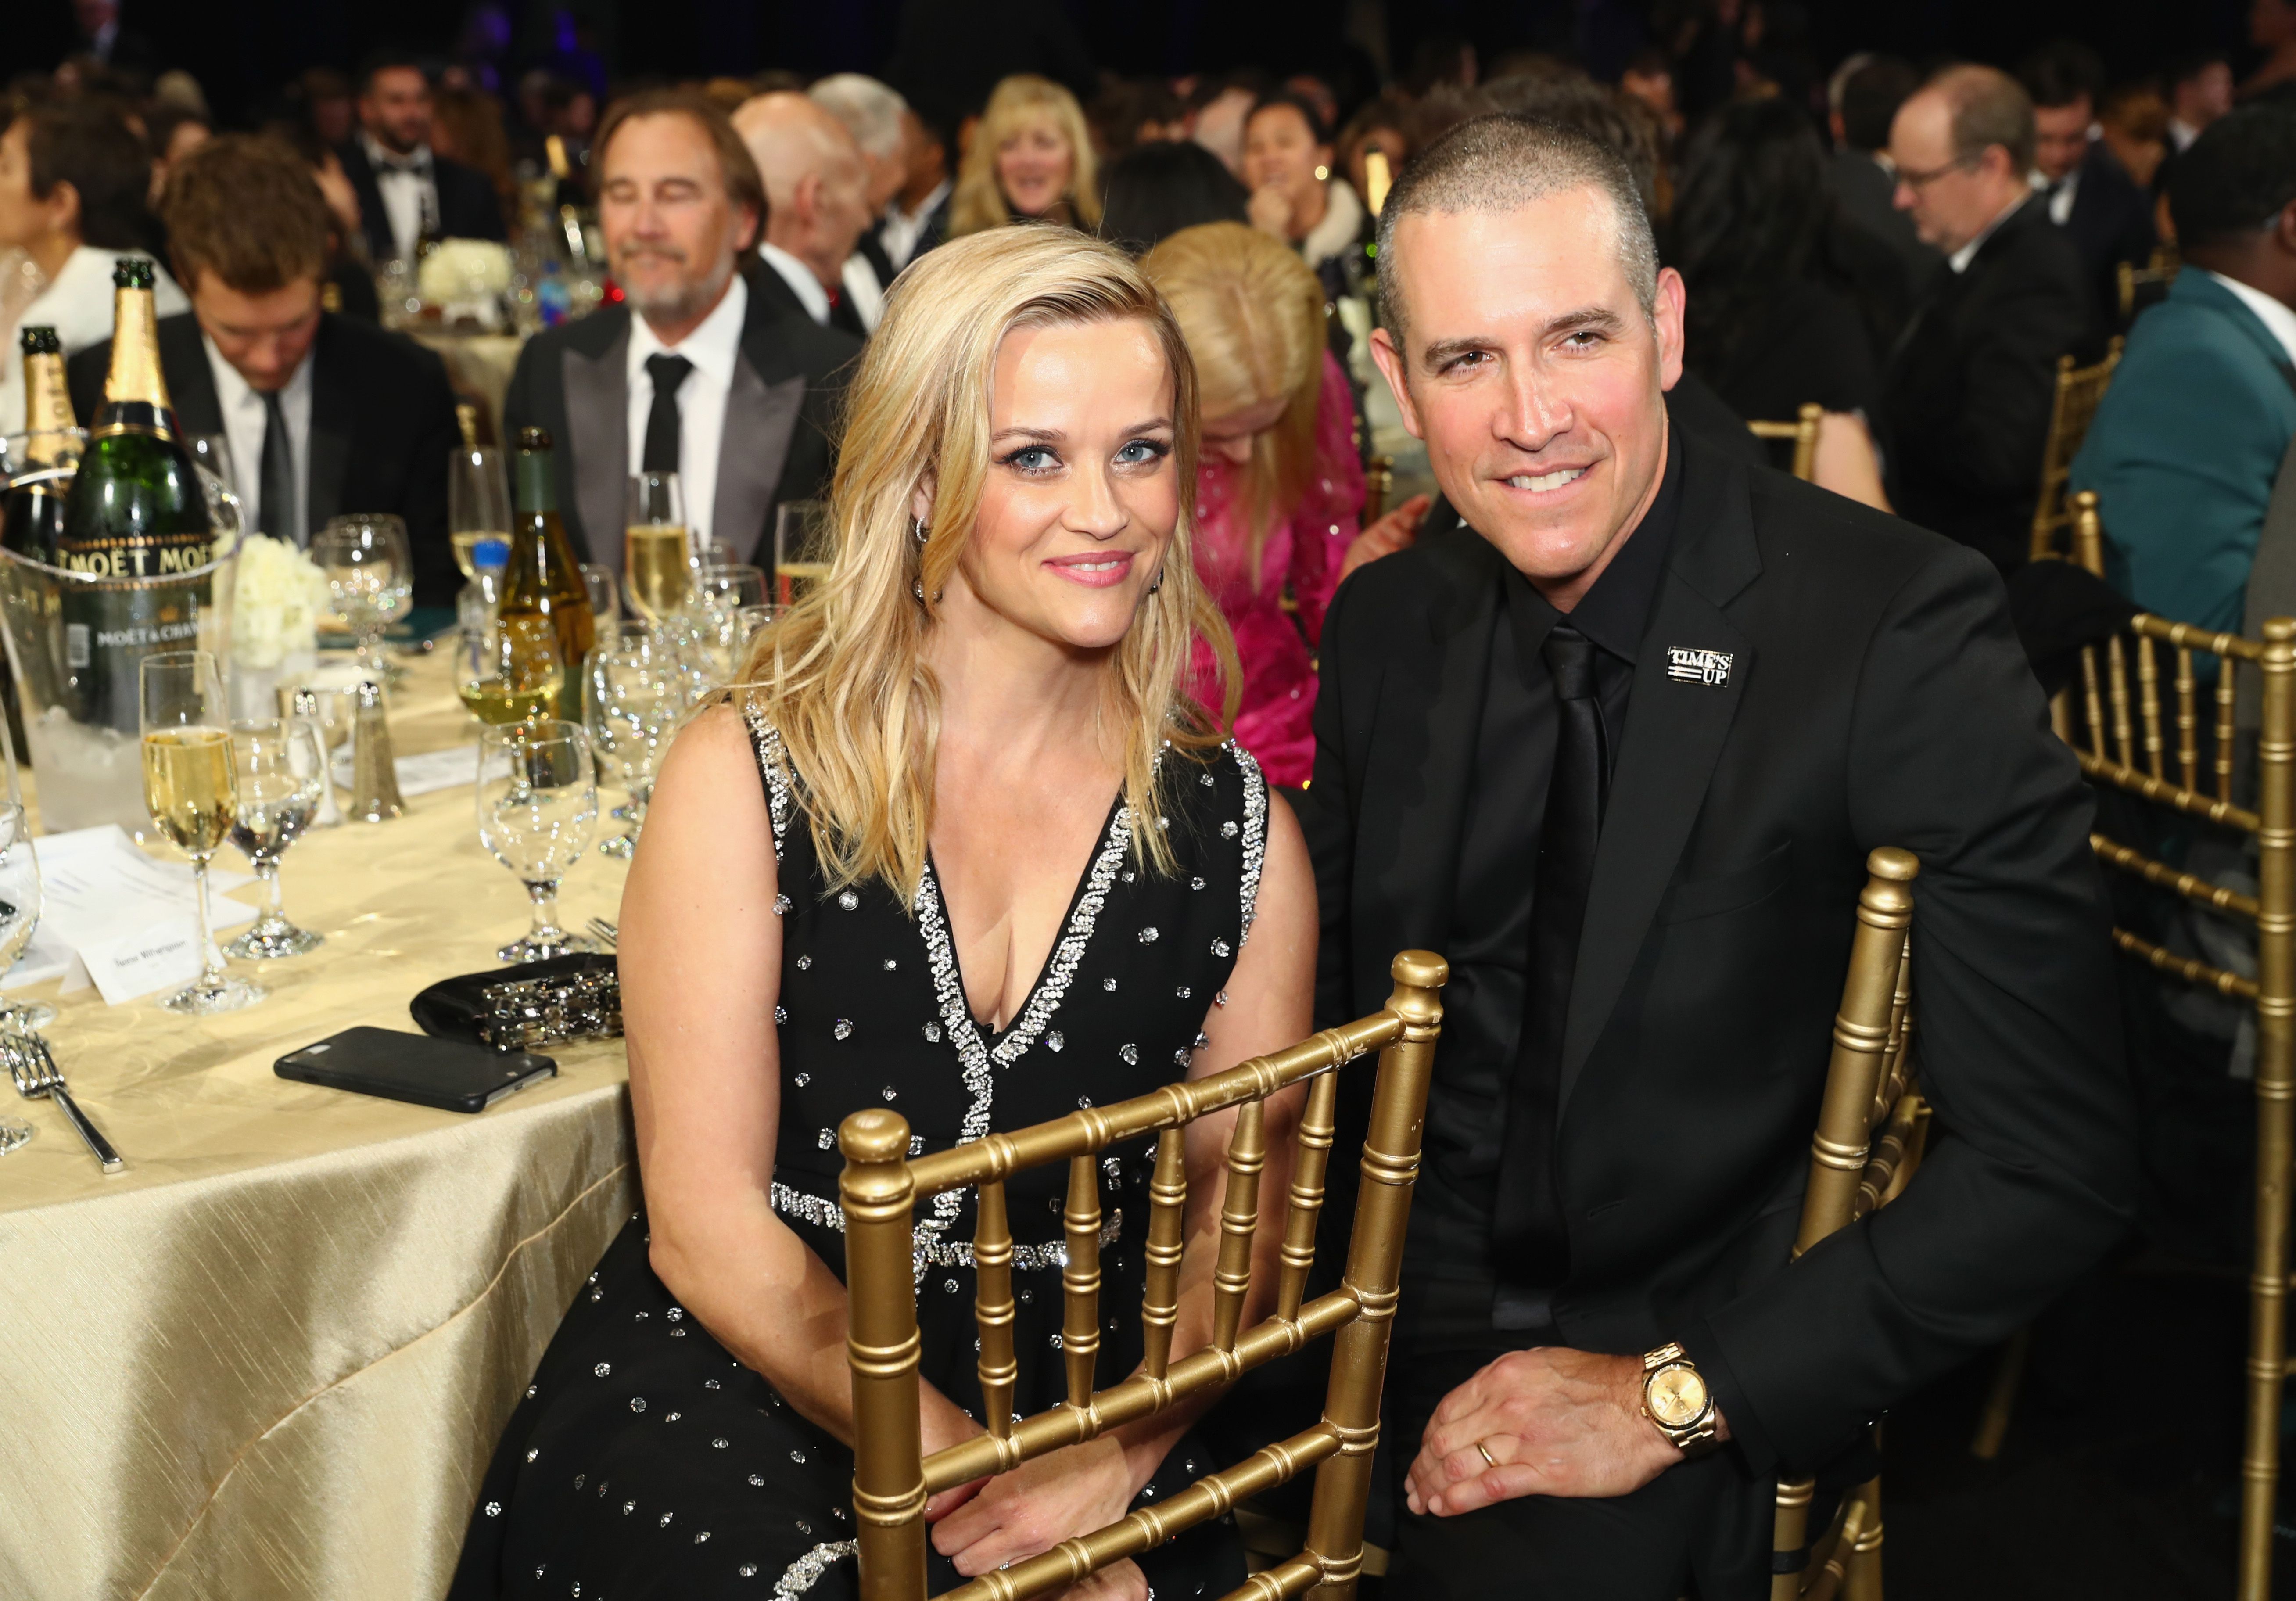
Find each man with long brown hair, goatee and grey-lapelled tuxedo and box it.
[503,90,861,572]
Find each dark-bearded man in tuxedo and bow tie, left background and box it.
[340,55,510,262]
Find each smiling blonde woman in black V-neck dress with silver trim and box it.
[452,227,1316,1601]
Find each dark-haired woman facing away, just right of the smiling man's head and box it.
[1669,99,1880,420]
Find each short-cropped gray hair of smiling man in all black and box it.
[1378,115,1658,345]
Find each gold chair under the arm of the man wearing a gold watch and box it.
[1770,845,1929,1601]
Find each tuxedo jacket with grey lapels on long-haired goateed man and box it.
[503,269,861,572]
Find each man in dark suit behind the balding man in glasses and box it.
[2018,39,2154,319]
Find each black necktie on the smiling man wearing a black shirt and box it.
[1490,622,1607,1328]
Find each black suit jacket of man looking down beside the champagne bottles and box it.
[67,312,462,607]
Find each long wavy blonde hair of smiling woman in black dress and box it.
[744,227,1240,905]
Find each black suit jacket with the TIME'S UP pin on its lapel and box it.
[1299,436,2135,1594]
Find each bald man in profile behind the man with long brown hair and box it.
[732,92,884,340]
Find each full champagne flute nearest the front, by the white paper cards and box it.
[140,650,264,1015]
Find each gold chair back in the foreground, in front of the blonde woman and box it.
[838,951,1449,1601]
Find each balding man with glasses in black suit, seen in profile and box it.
[1880,67,2092,572]
